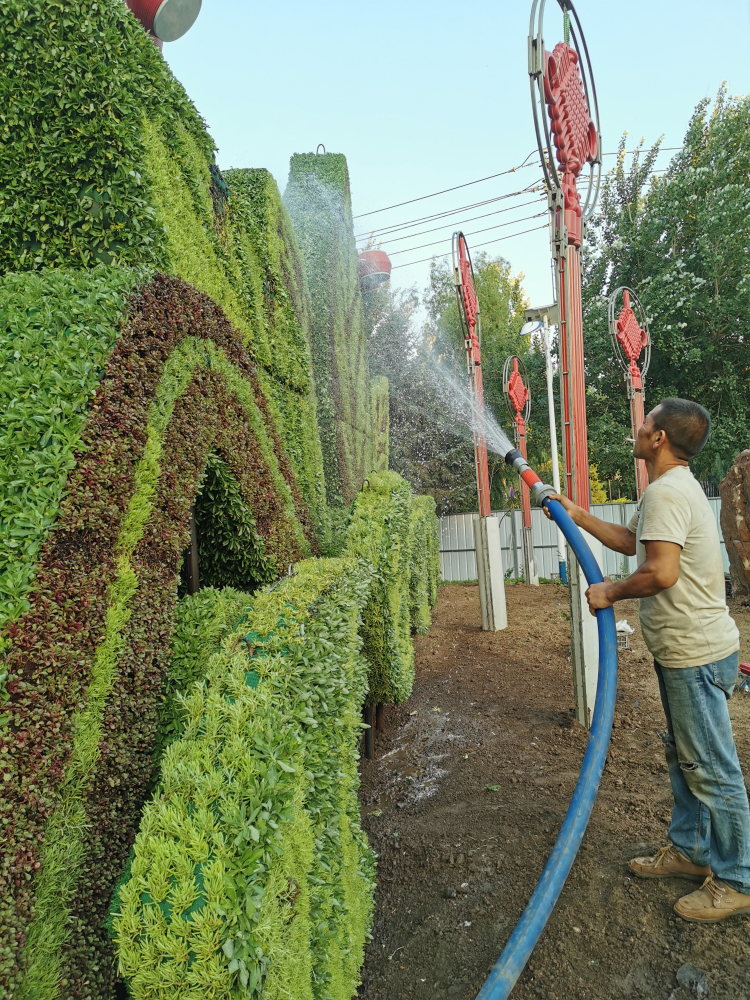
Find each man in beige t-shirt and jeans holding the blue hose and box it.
[555,399,750,923]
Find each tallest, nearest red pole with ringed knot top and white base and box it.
[528,0,601,727]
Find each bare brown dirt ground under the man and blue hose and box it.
[358,584,750,1000]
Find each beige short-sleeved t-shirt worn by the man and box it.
[628,466,740,667]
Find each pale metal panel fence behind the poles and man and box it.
[440,497,729,583]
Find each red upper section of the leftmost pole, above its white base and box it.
[453,233,492,517]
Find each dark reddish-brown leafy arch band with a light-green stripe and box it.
[0,275,314,998]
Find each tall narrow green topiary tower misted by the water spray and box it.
[284,153,372,505]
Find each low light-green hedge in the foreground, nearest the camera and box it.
[113,558,374,1000]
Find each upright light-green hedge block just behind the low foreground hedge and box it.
[347,472,414,705]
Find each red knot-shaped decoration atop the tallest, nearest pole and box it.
[544,42,598,247]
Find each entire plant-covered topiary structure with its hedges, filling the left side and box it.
[0,0,436,1000]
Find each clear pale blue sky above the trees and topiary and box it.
[164,0,750,305]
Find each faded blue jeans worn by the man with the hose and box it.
[654,653,750,893]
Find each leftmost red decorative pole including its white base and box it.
[452,232,508,632]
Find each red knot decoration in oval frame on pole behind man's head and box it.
[608,285,651,500]
